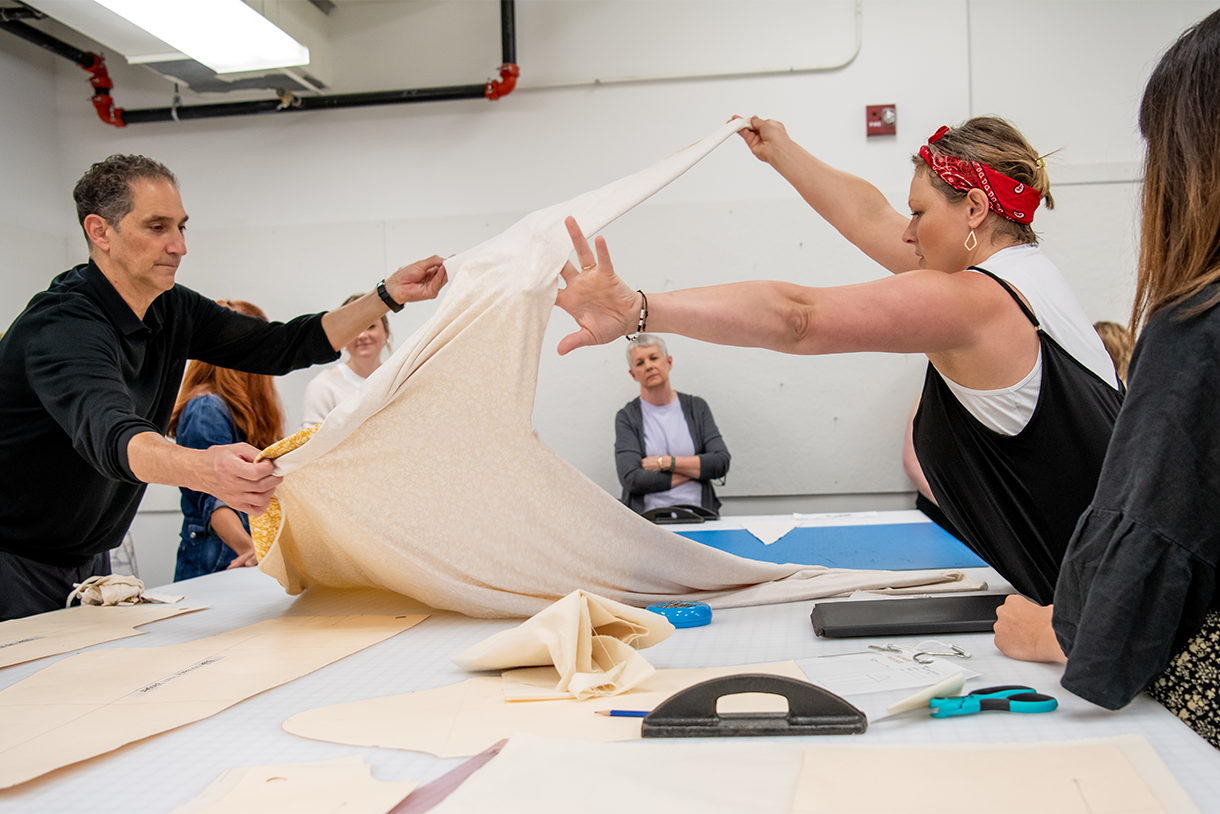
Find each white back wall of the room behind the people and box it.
[7,0,1209,585]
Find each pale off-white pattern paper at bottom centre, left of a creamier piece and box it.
[431,735,805,814]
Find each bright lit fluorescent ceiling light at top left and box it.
[96,0,309,73]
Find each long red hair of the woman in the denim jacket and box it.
[167,299,284,449]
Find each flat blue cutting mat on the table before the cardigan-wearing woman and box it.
[671,522,987,571]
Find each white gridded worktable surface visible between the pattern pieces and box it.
[0,519,1220,814]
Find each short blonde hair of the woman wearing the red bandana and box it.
[911,116,1055,245]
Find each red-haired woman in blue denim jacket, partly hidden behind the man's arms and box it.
[168,300,284,581]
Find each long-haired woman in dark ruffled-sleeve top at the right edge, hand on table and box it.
[996,12,1220,748]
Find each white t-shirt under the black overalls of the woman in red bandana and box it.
[942,244,1119,436]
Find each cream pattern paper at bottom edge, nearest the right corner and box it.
[791,736,1193,814]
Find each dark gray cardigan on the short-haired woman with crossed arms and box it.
[614,393,731,513]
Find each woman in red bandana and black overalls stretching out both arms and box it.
[556,117,1121,604]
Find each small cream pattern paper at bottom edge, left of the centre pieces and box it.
[172,754,418,814]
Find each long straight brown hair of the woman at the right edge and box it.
[1130,12,1220,331]
